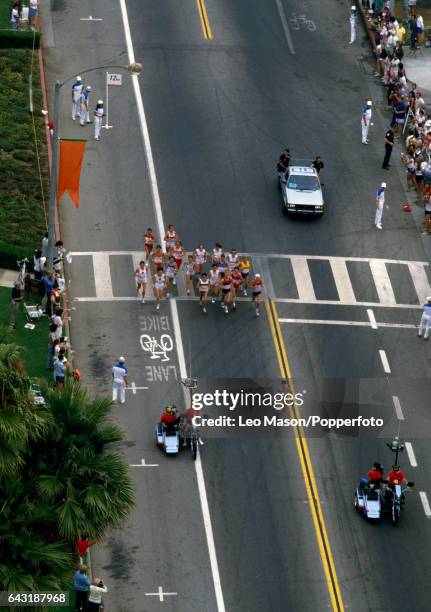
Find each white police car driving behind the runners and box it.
[279,160,325,215]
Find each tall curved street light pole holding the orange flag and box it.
[46,62,142,270]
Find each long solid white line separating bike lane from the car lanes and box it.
[120,0,225,612]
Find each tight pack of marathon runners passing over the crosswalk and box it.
[135,225,263,316]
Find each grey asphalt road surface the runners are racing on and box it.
[44,0,431,612]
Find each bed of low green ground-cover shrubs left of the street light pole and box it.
[0,45,49,260]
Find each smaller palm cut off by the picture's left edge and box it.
[0,344,50,477]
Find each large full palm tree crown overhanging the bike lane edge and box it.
[29,381,134,543]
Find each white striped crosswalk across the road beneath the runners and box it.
[72,251,431,309]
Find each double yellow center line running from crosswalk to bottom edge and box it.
[265,299,344,612]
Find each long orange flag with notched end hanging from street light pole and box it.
[57,140,87,208]
